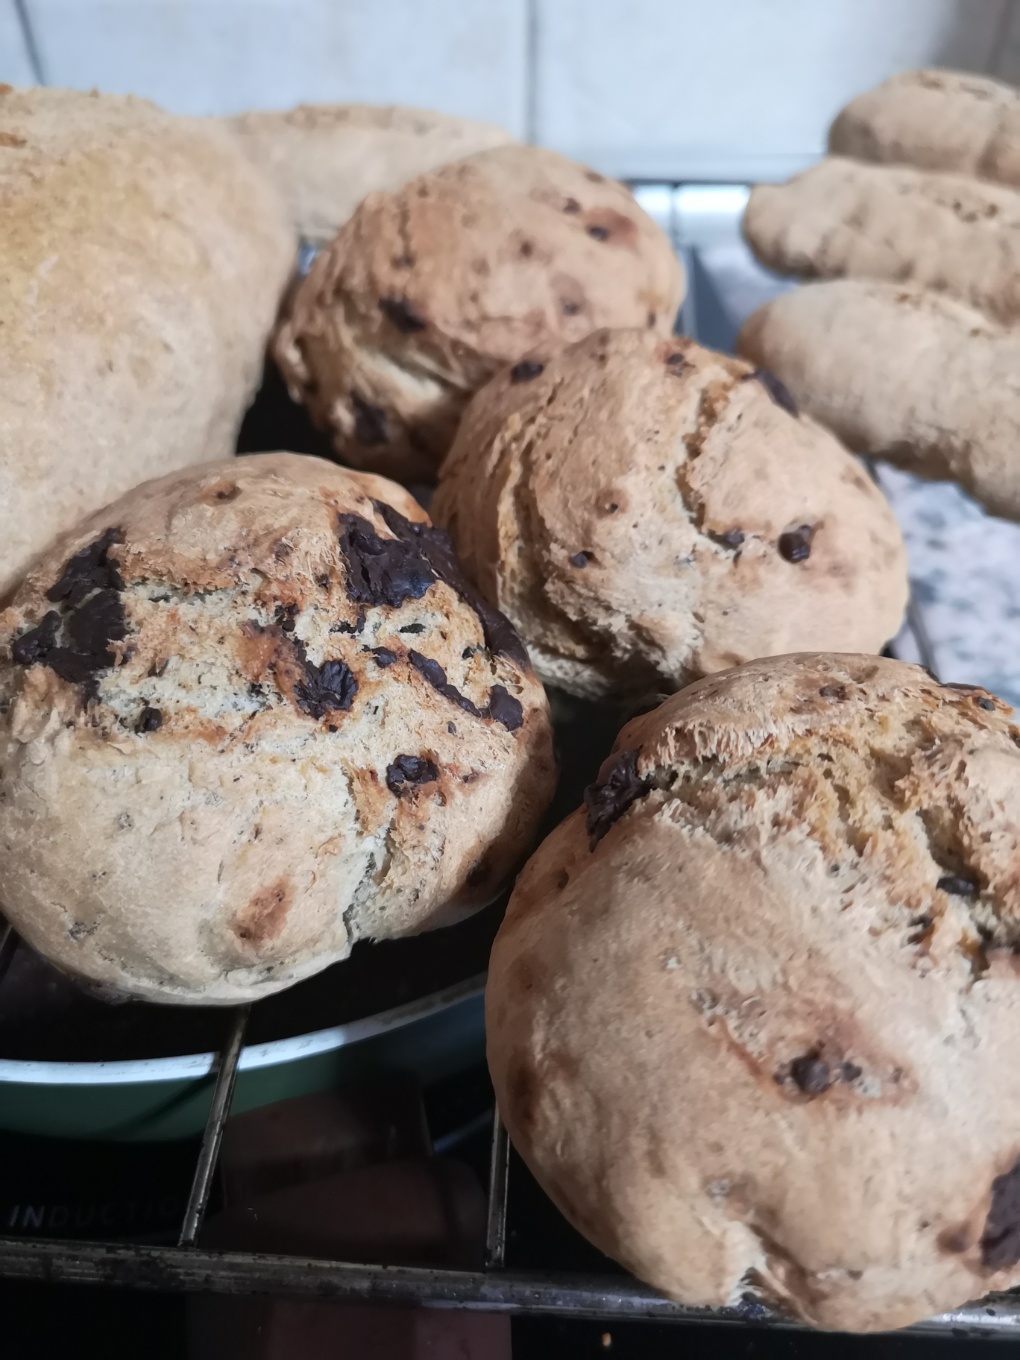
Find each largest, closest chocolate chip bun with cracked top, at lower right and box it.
[486,654,1020,1330]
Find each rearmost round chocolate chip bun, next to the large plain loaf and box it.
[275,146,684,480]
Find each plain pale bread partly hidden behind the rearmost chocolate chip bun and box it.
[226,103,514,245]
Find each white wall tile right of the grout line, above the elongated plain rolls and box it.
[536,0,1008,178]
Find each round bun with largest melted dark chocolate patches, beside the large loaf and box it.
[0,453,554,1005]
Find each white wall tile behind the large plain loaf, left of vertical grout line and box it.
[26,0,526,135]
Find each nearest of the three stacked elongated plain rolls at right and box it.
[738,279,1020,520]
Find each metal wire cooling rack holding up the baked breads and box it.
[0,185,1020,1340]
